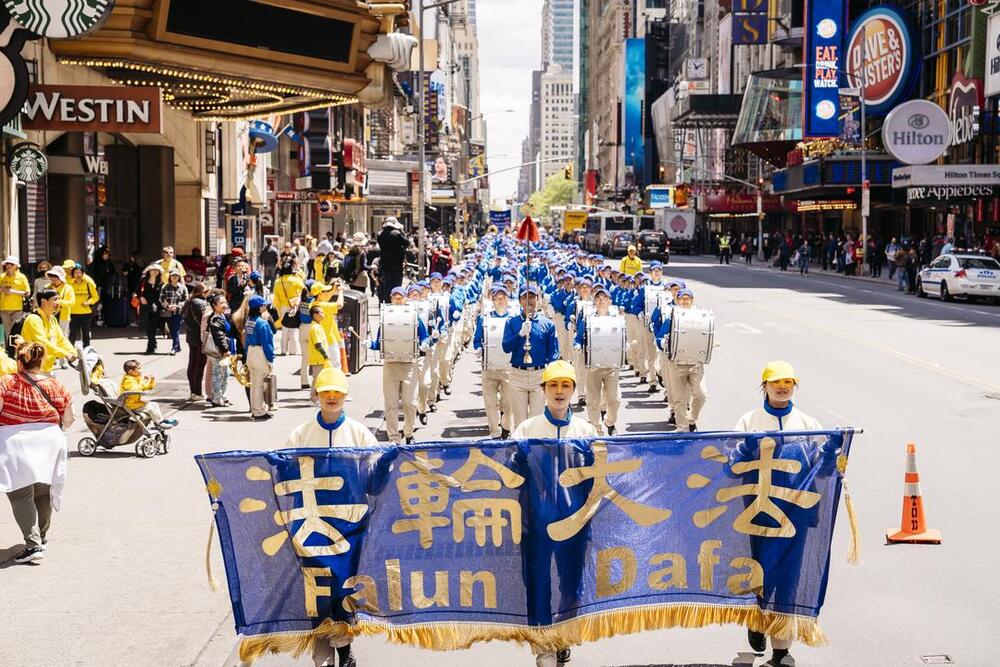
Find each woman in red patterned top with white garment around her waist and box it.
[0,342,73,564]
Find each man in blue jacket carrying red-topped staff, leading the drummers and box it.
[503,284,559,428]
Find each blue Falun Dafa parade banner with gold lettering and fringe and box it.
[196,429,854,661]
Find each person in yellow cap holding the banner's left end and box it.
[285,368,378,667]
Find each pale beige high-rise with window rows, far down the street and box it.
[538,64,576,187]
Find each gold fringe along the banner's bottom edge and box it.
[240,604,827,664]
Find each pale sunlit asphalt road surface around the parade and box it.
[0,258,1000,667]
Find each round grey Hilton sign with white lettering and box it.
[882,100,952,164]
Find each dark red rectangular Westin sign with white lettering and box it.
[23,85,163,134]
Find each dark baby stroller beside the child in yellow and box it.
[76,347,170,459]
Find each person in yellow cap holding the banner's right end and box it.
[730,361,837,667]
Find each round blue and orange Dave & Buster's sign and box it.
[846,5,919,115]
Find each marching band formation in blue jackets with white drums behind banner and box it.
[370,230,715,443]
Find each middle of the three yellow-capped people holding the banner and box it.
[514,360,597,667]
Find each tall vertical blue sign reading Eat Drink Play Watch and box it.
[802,0,847,139]
